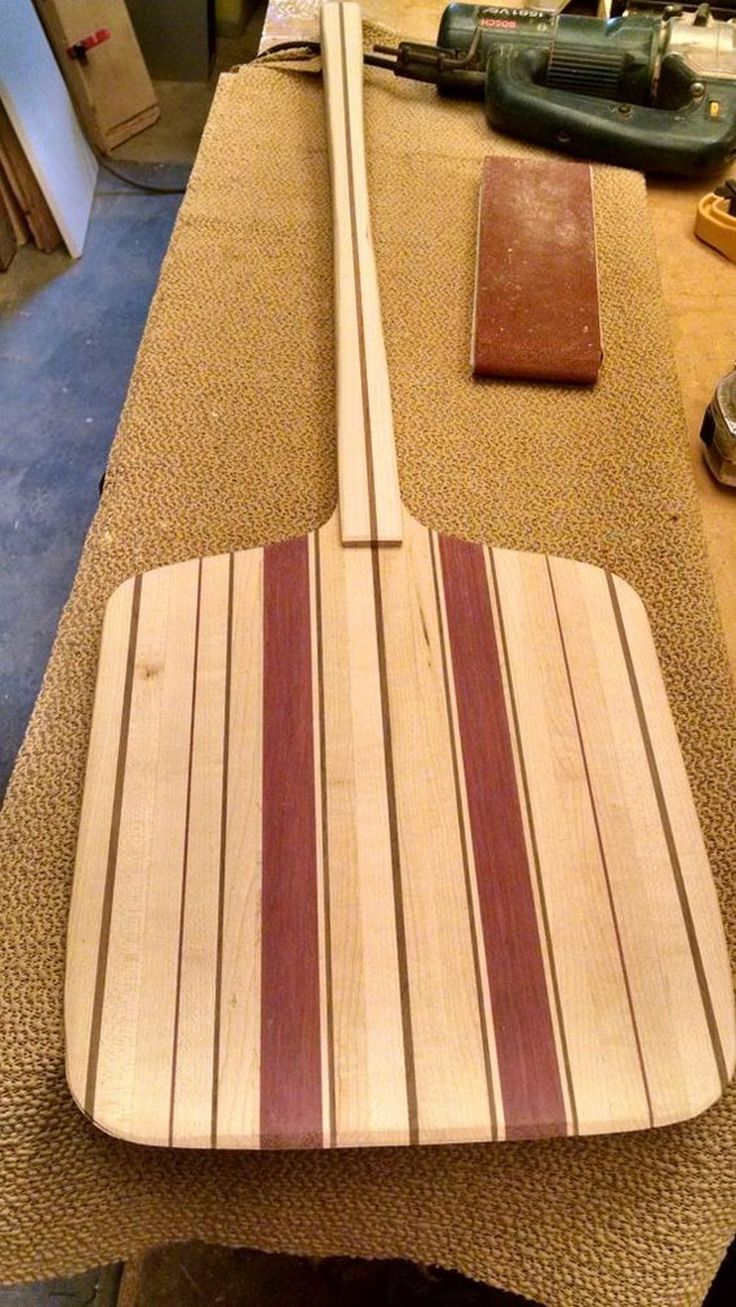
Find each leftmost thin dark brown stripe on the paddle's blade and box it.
[85,576,142,1117]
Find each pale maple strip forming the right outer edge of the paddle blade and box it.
[612,578,736,1092]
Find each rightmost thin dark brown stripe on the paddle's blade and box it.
[605,571,729,1090]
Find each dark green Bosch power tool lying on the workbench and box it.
[366,4,736,175]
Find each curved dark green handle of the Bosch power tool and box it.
[485,46,736,175]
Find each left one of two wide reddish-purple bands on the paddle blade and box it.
[260,536,323,1148]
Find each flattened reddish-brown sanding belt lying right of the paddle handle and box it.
[471,158,603,384]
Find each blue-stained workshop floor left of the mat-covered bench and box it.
[0,0,265,801]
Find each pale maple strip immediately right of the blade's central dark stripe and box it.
[380,514,493,1142]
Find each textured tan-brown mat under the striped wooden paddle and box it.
[0,35,736,1307]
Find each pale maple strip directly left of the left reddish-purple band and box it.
[216,549,263,1148]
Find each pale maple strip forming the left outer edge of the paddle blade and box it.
[64,579,136,1111]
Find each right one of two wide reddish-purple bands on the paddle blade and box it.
[439,536,567,1138]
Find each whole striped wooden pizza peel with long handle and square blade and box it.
[65,0,735,1149]
